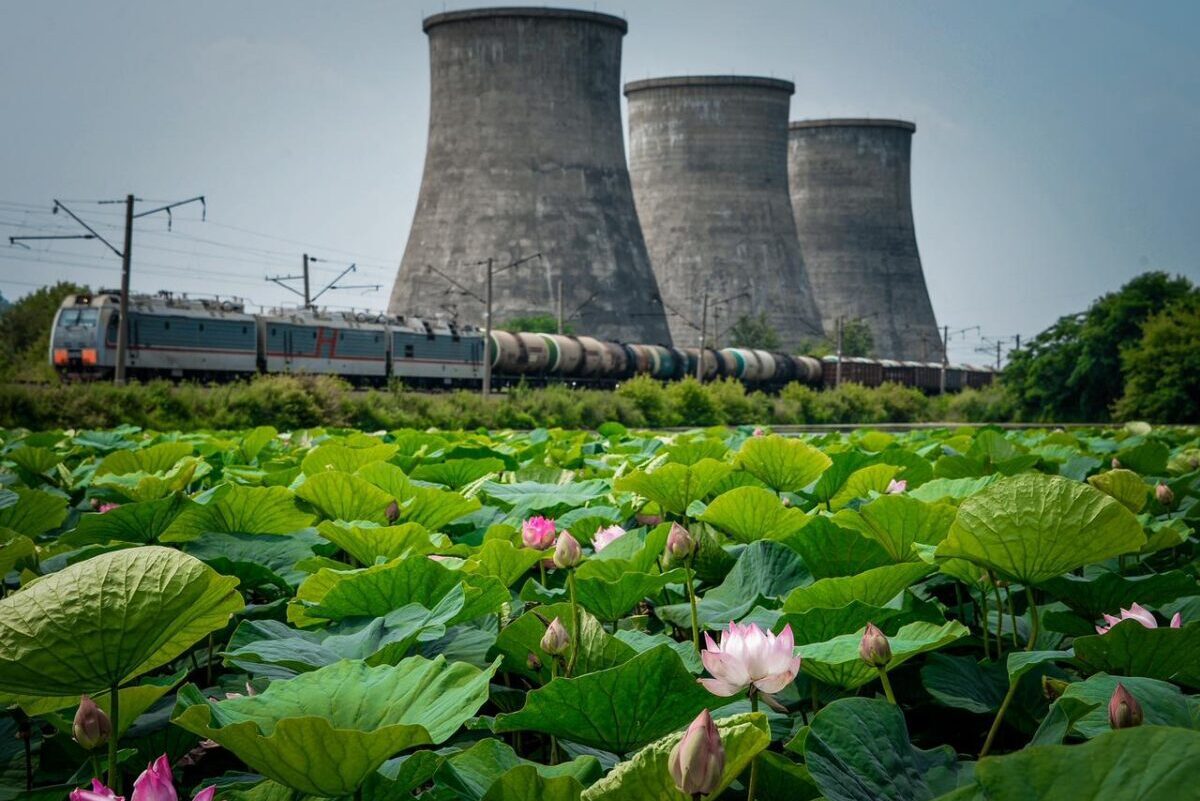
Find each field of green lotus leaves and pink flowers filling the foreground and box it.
[0,424,1200,801]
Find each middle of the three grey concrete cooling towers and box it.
[625,76,822,348]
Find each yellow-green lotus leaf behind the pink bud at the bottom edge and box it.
[573,712,770,801]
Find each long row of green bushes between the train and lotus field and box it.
[0,375,1013,430]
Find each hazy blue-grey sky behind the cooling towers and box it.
[0,0,1200,362]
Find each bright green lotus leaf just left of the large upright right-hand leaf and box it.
[833,495,955,562]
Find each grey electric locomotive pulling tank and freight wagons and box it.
[49,290,995,392]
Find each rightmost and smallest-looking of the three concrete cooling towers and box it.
[787,120,942,361]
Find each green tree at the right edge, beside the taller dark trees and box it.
[1116,293,1200,423]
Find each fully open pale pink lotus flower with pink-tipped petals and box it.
[698,621,800,695]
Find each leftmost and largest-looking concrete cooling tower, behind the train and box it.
[389,8,670,343]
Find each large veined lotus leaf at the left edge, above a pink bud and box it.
[0,546,244,695]
